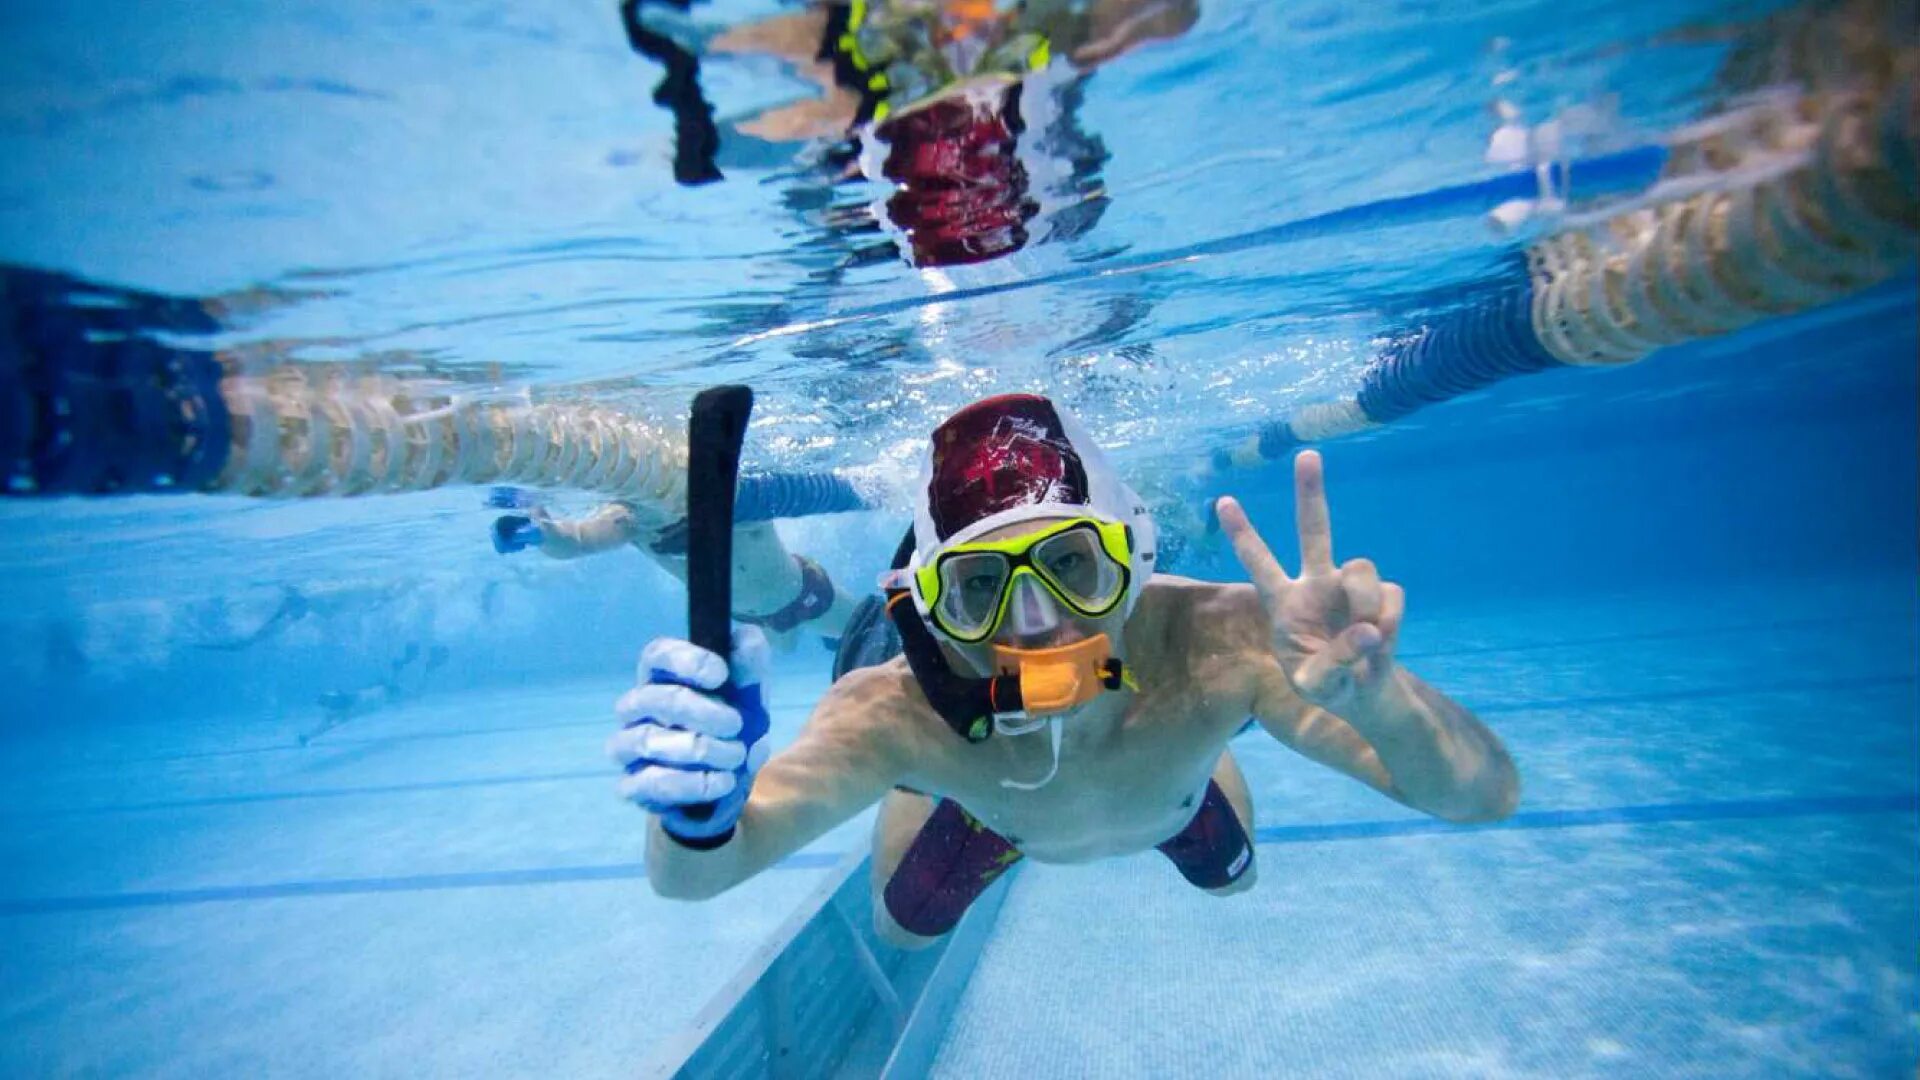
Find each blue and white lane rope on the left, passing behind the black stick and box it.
[0,267,883,527]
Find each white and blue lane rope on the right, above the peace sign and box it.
[1212,22,1920,471]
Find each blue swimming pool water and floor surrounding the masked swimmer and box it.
[0,2,1920,1076]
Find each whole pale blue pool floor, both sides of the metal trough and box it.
[0,575,1920,1078]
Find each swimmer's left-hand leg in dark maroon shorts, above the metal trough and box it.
[874,788,1020,949]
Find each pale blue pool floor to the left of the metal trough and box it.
[0,664,870,1076]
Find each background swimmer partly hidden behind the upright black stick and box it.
[488,488,858,648]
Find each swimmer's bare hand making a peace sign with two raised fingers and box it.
[1217,450,1405,715]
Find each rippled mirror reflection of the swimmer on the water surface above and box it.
[622,0,1198,267]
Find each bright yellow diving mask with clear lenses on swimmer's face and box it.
[912,517,1133,644]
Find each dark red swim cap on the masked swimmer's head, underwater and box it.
[927,394,1092,540]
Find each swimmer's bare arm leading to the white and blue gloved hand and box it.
[647,669,902,899]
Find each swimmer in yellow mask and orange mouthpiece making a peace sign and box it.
[607,396,1519,947]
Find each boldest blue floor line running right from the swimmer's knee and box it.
[1254,792,1920,844]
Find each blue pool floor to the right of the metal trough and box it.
[933,577,1920,1080]
